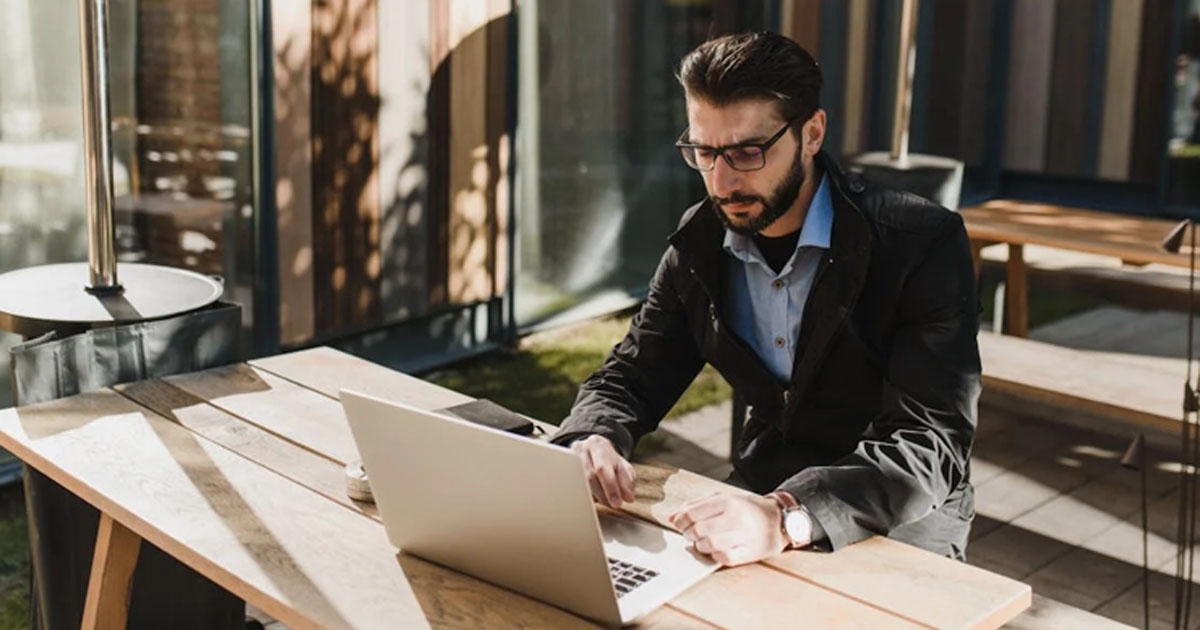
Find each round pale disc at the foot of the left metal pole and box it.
[0,263,224,338]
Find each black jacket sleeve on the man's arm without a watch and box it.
[551,247,704,458]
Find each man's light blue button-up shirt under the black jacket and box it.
[725,170,833,383]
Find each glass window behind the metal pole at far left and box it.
[0,0,256,398]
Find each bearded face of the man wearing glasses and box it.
[688,98,811,235]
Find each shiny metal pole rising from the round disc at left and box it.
[79,0,121,293]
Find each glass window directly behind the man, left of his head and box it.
[515,0,770,329]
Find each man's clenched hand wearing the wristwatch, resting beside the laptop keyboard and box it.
[668,494,787,566]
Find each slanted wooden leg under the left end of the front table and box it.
[82,514,142,630]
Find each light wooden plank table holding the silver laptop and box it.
[0,348,1031,630]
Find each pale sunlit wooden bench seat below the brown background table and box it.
[979,331,1184,434]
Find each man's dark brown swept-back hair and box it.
[678,32,822,122]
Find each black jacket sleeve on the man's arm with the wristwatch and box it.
[780,215,980,550]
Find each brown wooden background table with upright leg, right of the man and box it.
[960,199,1190,337]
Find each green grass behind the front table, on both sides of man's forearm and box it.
[426,314,731,425]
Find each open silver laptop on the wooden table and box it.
[342,390,716,625]
